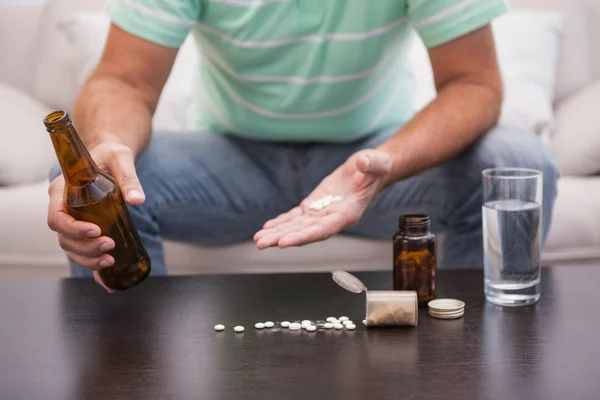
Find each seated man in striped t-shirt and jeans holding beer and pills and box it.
[48,0,558,292]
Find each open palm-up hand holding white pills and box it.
[254,150,392,250]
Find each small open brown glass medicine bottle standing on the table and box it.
[393,214,437,307]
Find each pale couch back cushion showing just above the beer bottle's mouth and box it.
[32,0,104,110]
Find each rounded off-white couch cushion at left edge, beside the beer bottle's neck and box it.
[0,82,56,186]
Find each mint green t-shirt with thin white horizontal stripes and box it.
[108,0,507,141]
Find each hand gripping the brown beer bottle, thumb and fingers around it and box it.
[48,142,144,293]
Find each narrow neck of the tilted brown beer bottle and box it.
[44,111,100,186]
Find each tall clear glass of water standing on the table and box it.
[482,168,543,306]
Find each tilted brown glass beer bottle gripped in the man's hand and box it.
[44,110,151,290]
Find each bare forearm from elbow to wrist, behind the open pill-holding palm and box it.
[378,80,502,184]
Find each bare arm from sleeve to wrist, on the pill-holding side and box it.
[378,25,502,185]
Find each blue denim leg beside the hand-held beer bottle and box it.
[50,133,298,276]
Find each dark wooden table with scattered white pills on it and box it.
[0,266,600,400]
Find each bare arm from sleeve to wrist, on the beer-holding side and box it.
[73,25,177,157]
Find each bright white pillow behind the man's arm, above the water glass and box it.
[410,11,562,136]
